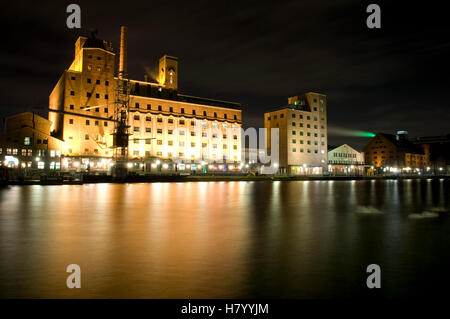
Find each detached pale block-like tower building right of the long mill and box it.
[264,92,328,174]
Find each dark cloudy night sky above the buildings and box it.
[0,0,450,149]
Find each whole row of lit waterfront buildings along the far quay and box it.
[0,27,450,175]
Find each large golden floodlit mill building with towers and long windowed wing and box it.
[49,29,242,170]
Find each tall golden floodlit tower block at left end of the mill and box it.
[49,37,116,156]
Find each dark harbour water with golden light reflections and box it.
[0,180,450,298]
